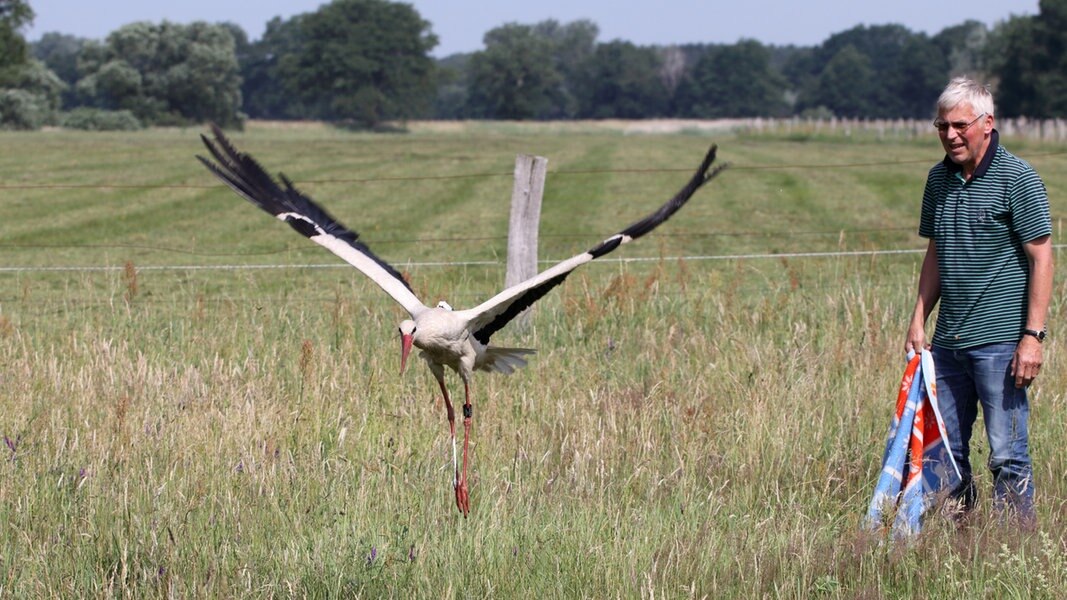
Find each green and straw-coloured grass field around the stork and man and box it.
[0,124,1067,599]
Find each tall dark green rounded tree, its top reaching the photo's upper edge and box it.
[274,0,437,126]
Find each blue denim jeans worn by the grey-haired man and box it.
[931,342,1034,521]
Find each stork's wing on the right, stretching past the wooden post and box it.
[462,145,728,344]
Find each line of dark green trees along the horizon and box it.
[0,0,1067,129]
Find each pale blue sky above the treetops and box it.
[22,0,1038,58]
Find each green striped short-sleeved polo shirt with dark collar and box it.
[919,129,1052,349]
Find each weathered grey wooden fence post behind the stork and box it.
[504,154,548,329]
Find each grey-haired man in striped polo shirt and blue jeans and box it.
[904,78,1052,524]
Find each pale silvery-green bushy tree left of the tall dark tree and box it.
[77,21,241,126]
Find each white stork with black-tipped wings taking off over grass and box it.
[196,125,726,517]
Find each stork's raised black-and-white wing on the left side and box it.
[196,125,426,316]
